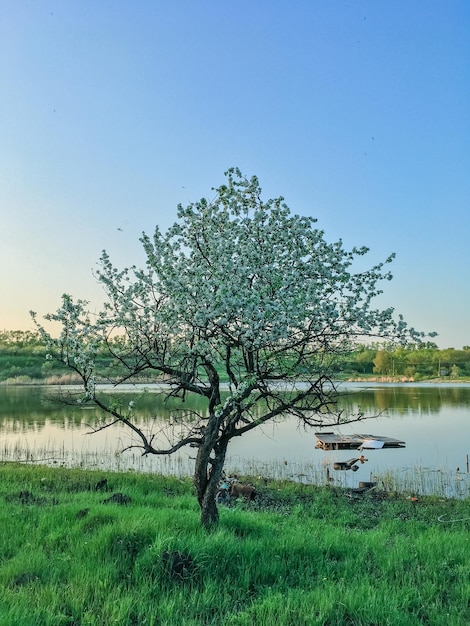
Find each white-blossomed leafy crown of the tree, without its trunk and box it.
[33,169,419,426]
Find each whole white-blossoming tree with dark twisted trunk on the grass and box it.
[33,169,419,527]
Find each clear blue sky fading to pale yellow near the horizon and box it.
[0,0,470,348]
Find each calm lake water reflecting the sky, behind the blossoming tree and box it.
[0,383,470,497]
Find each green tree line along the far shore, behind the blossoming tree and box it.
[0,330,470,383]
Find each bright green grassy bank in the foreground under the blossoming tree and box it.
[0,463,470,626]
